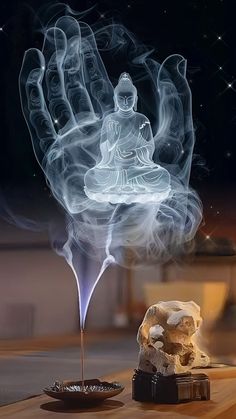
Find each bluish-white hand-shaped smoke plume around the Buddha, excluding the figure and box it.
[19,11,202,327]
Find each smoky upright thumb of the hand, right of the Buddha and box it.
[155,54,194,185]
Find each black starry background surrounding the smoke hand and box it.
[0,0,236,238]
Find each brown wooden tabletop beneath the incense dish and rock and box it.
[0,367,236,419]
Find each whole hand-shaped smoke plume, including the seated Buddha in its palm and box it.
[20,16,201,328]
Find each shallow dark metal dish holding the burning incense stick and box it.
[43,379,124,404]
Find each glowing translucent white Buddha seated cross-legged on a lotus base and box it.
[85,73,171,204]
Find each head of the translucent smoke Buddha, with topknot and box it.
[114,73,138,112]
